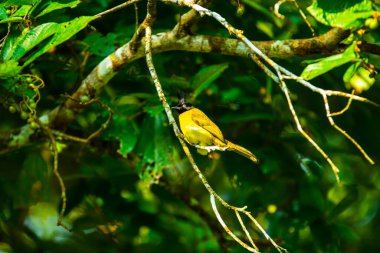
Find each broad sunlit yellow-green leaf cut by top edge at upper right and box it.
[307,0,373,29]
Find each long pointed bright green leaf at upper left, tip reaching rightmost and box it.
[23,16,98,67]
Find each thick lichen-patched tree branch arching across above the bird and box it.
[0,26,362,152]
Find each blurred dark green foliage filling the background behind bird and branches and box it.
[0,0,380,253]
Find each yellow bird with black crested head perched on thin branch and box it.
[172,95,259,163]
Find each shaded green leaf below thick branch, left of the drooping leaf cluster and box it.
[102,114,138,157]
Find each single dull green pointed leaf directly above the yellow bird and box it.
[191,63,228,98]
